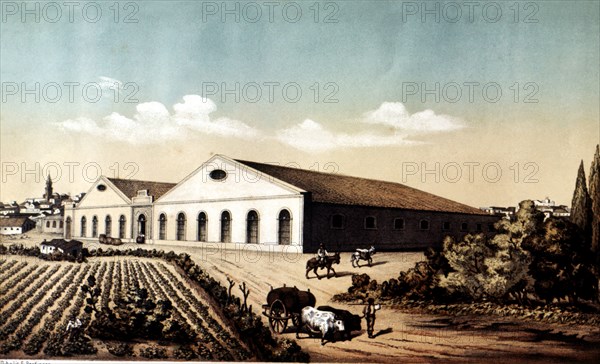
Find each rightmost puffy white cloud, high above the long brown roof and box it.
[363,102,465,134]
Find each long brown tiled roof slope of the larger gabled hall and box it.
[236,160,487,215]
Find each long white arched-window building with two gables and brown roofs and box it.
[65,155,496,251]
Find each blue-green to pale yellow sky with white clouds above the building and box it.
[0,1,600,207]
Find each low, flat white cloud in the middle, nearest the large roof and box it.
[277,119,421,152]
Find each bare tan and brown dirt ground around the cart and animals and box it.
[5,233,600,363]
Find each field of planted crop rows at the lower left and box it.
[0,257,252,361]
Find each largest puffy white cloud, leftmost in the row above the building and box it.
[58,95,260,144]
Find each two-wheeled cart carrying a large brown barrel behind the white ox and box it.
[262,286,317,334]
